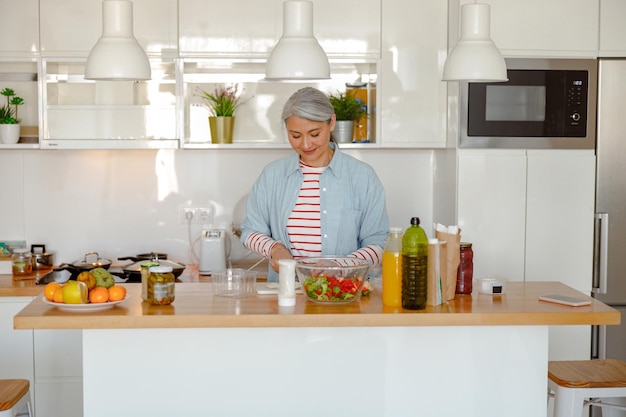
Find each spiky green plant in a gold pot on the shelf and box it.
[197,84,244,143]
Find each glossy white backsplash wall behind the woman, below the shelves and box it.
[0,149,433,263]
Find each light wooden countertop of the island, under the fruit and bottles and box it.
[14,282,620,329]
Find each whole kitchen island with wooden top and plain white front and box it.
[14,282,620,417]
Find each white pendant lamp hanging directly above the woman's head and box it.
[265,1,330,80]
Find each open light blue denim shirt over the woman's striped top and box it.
[241,143,389,281]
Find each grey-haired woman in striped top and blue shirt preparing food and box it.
[241,87,389,281]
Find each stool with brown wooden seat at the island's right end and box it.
[548,359,626,417]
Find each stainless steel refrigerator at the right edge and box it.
[591,59,626,361]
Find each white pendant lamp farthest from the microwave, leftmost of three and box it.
[85,0,151,81]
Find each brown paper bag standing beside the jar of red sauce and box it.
[435,224,461,303]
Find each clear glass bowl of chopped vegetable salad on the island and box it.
[296,256,371,304]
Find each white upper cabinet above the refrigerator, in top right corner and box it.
[598,0,626,57]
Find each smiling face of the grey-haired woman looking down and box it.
[285,114,335,167]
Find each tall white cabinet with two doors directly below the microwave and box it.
[457,150,595,360]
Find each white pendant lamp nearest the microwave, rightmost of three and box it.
[443,3,508,82]
